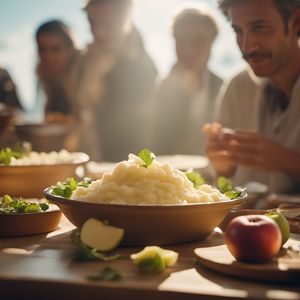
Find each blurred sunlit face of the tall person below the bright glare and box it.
[87,2,128,51]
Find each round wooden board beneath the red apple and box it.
[195,235,300,284]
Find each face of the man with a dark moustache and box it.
[229,0,297,77]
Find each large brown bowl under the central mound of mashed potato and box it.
[45,188,246,246]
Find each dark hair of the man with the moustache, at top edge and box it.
[218,0,300,30]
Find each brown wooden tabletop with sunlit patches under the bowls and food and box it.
[0,219,300,300]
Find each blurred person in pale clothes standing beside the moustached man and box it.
[150,6,222,155]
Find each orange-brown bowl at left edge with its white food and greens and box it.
[0,148,89,198]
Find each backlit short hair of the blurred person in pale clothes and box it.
[172,6,219,39]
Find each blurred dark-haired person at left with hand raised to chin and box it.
[36,20,80,121]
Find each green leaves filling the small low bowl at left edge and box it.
[0,195,49,214]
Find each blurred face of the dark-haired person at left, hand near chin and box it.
[38,33,74,76]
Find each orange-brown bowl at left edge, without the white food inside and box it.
[0,153,89,198]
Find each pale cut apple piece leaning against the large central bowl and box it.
[80,219,124,252]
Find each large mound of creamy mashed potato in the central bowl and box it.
[71,154,229,205]
